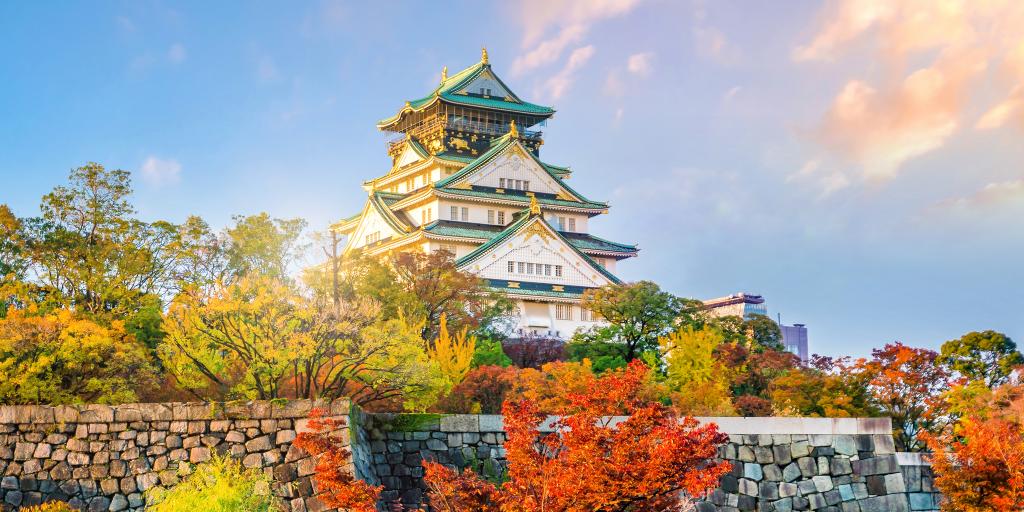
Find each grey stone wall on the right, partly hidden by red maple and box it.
[360,415,939,512]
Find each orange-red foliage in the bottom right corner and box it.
[924,419,1024,512]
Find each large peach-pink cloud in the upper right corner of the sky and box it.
[792,0,1024,180]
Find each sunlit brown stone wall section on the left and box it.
[0,399,350,512]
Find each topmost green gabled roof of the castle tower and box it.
[377,53,555,129]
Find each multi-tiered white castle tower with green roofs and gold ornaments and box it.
[334,50,637,338]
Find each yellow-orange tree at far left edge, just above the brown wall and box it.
[0,305,154,403]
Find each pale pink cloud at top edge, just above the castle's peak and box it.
[512,0,641,75]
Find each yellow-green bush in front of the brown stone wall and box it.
[146,456,281,512]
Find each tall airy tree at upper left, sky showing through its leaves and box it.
[25,163,177,317]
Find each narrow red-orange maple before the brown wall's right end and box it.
[295,409,383,512]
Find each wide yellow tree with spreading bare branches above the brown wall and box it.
[160,276,444,409]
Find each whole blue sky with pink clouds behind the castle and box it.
[0,0,1024,355]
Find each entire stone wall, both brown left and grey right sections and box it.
[0,400,939,512]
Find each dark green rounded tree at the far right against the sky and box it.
[938,331,1024,387]
